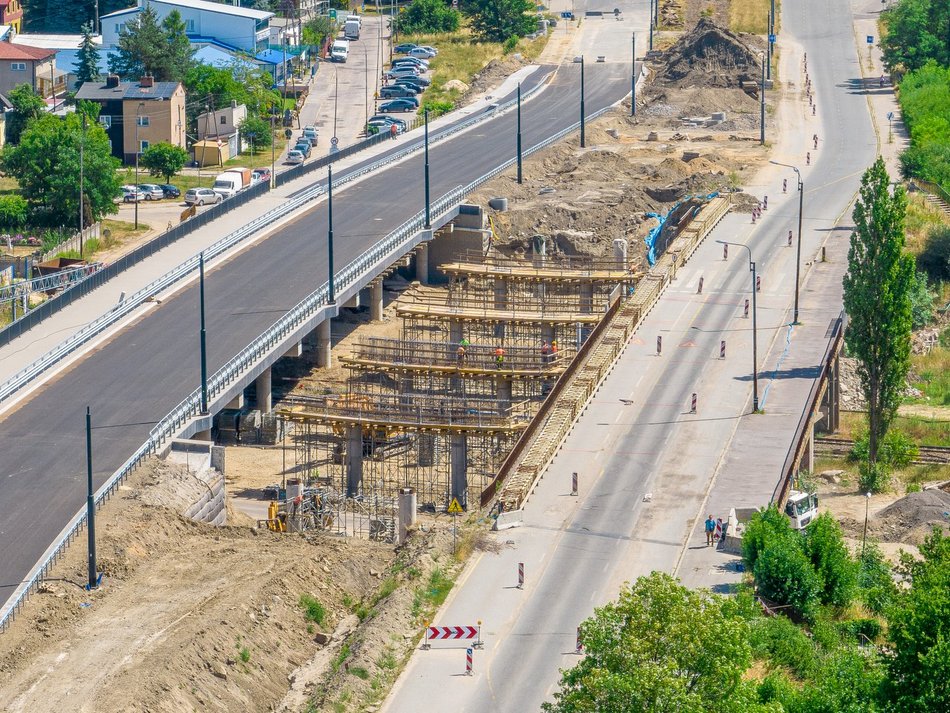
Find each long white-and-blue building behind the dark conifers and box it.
[100,0,274,54]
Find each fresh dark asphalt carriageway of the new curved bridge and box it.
[0,63,629,612]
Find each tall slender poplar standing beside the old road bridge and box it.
[844,157,914,490]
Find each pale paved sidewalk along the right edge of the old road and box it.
[676,0,907,591]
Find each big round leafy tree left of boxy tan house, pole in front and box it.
[2,111,120,225]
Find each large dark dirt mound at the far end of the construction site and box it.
[654,17,759,87]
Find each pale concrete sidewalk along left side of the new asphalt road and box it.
[0,65,552,394]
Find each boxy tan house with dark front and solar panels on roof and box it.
[76,74,186,164]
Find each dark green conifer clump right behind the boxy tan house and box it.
[109,3,195,82]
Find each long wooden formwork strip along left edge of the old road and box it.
[481,198,729,511]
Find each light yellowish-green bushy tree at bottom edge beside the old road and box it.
[543,572,754,713]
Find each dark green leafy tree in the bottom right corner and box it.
[885,528,950,713]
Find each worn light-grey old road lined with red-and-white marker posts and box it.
[383,0,876,713]
